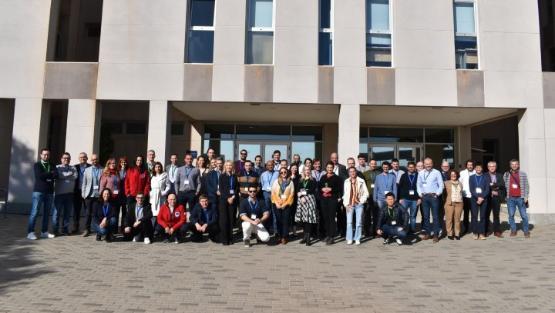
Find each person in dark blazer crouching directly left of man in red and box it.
[123,193,152,244]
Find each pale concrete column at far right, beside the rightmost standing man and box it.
[517,108,554,223]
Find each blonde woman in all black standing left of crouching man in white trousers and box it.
[218,161,239,246]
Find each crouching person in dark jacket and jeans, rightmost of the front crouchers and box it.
[378,192,408,245]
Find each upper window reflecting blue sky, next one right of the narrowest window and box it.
[366,0,391,67]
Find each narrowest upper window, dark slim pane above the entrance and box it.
[318,0,333,65]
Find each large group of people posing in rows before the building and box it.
[27,148,530,246]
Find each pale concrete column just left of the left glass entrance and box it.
[145,100,171,165]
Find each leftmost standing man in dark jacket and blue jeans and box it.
[27,148,56,240]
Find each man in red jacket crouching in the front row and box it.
[156,193,187,243]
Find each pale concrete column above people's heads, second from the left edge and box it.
[65,99,102,158]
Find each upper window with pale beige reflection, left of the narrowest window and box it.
[245,0,274,64]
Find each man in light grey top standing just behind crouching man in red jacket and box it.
[175,153,201,211]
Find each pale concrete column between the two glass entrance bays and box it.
[337,104,360,164]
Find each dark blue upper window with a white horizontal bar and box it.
[186,0,215,63]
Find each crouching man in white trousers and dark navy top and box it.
[239,187,270,247]
